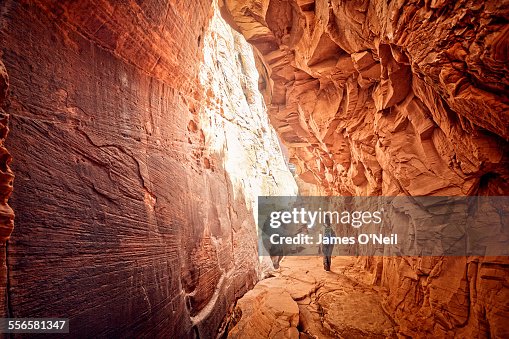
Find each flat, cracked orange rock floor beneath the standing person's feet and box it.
[229,257,397,338]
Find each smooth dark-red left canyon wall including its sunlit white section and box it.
[0,1,296,338]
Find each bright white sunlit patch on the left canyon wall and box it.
[197,5,297,209]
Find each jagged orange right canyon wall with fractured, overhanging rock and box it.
[221,0,509,337]
